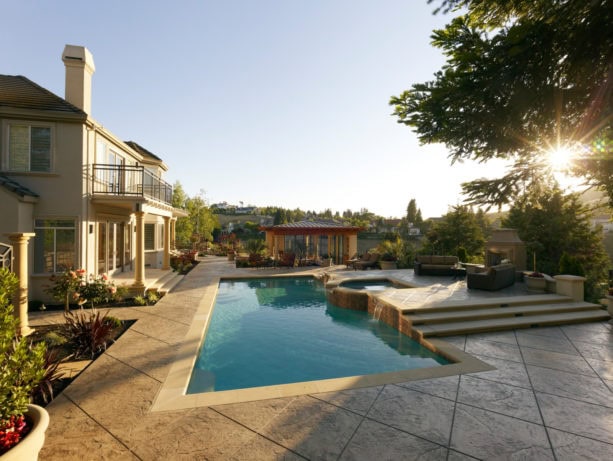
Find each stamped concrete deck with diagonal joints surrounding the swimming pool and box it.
[31,257,613,460]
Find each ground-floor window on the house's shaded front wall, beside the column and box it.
[34,219,77,273]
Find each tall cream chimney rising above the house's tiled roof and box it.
[62,45,96,114]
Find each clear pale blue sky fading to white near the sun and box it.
[0,0,503,218]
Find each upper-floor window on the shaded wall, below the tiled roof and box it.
[8,124,51,172]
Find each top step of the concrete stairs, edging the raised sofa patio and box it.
[402,293,572,315]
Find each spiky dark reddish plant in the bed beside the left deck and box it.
[64,308,115,358]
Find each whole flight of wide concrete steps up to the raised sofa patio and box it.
[404,294,611,337]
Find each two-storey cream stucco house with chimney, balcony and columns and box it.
[0,45,185,301]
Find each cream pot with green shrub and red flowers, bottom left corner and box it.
[0,268,49,461]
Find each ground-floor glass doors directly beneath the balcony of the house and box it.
[98,220,132,274]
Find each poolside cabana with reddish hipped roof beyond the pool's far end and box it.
[260,221,363,264]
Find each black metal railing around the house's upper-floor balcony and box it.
[92,163,172,205]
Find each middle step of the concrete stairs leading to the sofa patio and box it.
[405,301,599,325]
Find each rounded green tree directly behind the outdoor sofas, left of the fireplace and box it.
[423,205,485,258]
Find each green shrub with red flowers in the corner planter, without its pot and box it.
[0,268,46,454]
